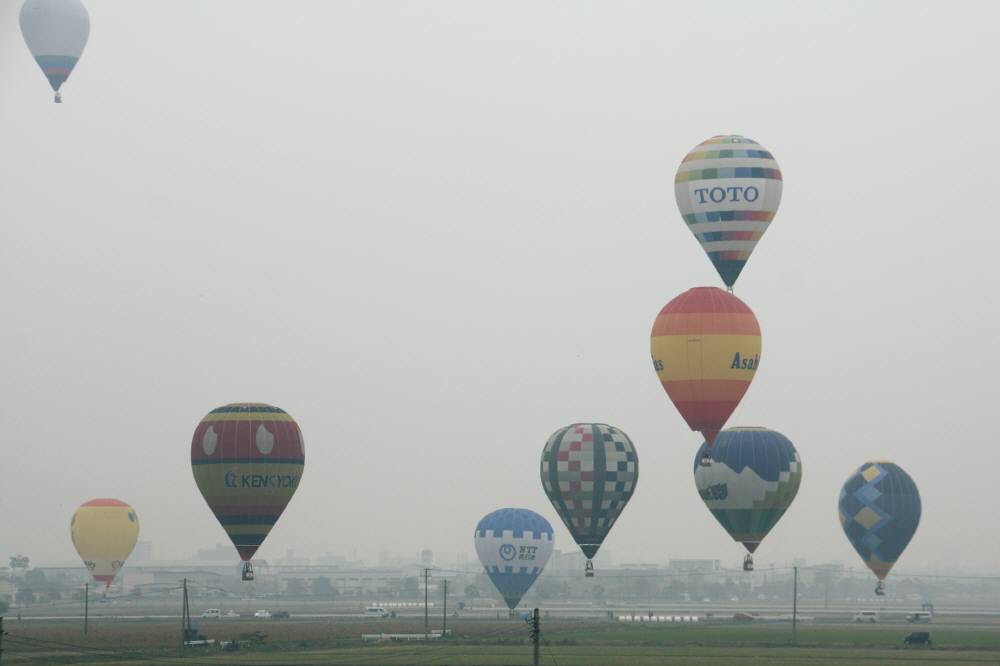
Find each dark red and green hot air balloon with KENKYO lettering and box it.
[191,403,305,580]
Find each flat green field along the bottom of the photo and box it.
[3,620,1000,666]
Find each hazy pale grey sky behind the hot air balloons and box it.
[0,0,1000,571]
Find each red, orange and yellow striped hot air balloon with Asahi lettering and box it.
[651,287,760,455]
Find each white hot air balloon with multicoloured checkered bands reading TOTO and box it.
[674,134,782,291]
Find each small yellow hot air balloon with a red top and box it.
[69,499,139,590]
